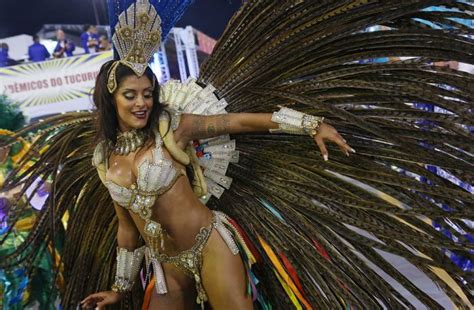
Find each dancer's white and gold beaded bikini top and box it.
[92,132,183,237]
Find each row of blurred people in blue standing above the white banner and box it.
[0,25,112,67]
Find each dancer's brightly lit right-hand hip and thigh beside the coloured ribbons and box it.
[201,229,253,310]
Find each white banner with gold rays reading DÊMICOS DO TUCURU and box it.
[0,52,112,117]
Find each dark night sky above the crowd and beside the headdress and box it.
[0,0,242,38]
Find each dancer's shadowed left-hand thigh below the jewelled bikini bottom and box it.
[148,264,197,310]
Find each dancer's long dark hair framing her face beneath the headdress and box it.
[92,60,164,144]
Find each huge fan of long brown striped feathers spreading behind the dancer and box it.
[0,0,474,309]
